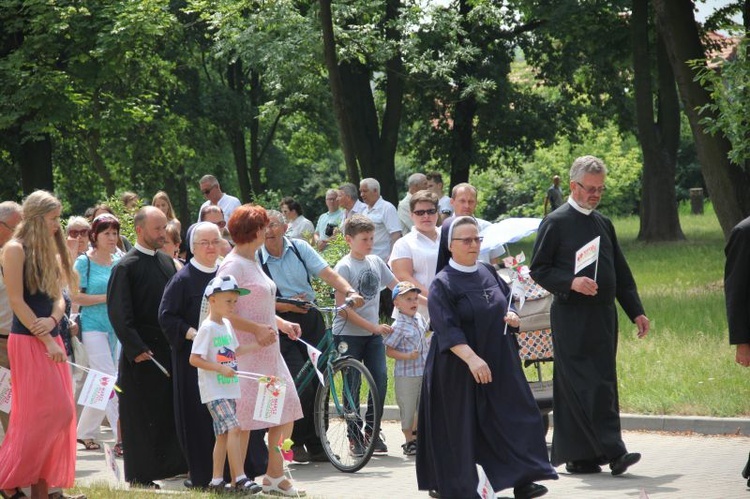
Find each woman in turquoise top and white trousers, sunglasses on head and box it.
[73,213,122,455]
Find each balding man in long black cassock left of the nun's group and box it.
[107,206,187,487]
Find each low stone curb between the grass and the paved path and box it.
[383,405,750,436]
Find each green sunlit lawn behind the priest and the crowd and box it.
[386,205,750,417]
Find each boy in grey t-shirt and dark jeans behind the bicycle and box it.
[333,215,397,457]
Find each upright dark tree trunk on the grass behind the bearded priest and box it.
[632,0,685,241]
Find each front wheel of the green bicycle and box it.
[315,359,382,473]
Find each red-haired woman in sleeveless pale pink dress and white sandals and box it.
[217,204,304,497]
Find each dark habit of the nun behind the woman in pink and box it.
[159,263,268,487]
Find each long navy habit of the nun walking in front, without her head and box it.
[417,263,557,499]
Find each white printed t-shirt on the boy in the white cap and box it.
[190,317,240,404]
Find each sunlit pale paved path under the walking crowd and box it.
[76,422,750,499]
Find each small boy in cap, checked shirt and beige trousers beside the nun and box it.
[383,281,429,456]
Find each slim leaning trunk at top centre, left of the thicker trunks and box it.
[320,0,361,185]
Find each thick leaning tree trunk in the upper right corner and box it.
[654,0,750,236]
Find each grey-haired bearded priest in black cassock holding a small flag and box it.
[531,156,649,475]
